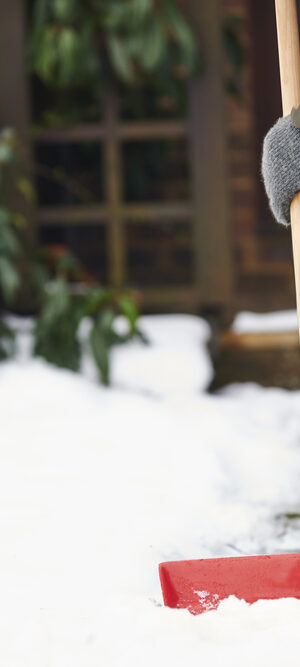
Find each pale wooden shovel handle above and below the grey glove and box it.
[275,0,300,333]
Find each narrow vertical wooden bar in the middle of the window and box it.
[104,92,126,287]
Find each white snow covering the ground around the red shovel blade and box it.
[0,316,300,667]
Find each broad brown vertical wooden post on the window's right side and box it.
[189,0,233,304]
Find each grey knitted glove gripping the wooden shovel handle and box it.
[262,109,300,225]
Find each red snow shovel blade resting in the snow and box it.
[159,554,300,614]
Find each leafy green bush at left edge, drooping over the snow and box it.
[0,129,145,384]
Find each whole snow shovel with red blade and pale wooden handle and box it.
[159,0,300,614]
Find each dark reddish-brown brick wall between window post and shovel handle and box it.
[222,0,295,310]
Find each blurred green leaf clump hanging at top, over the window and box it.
[30,0,199,91]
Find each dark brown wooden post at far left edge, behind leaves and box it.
[0,0,33,237]
